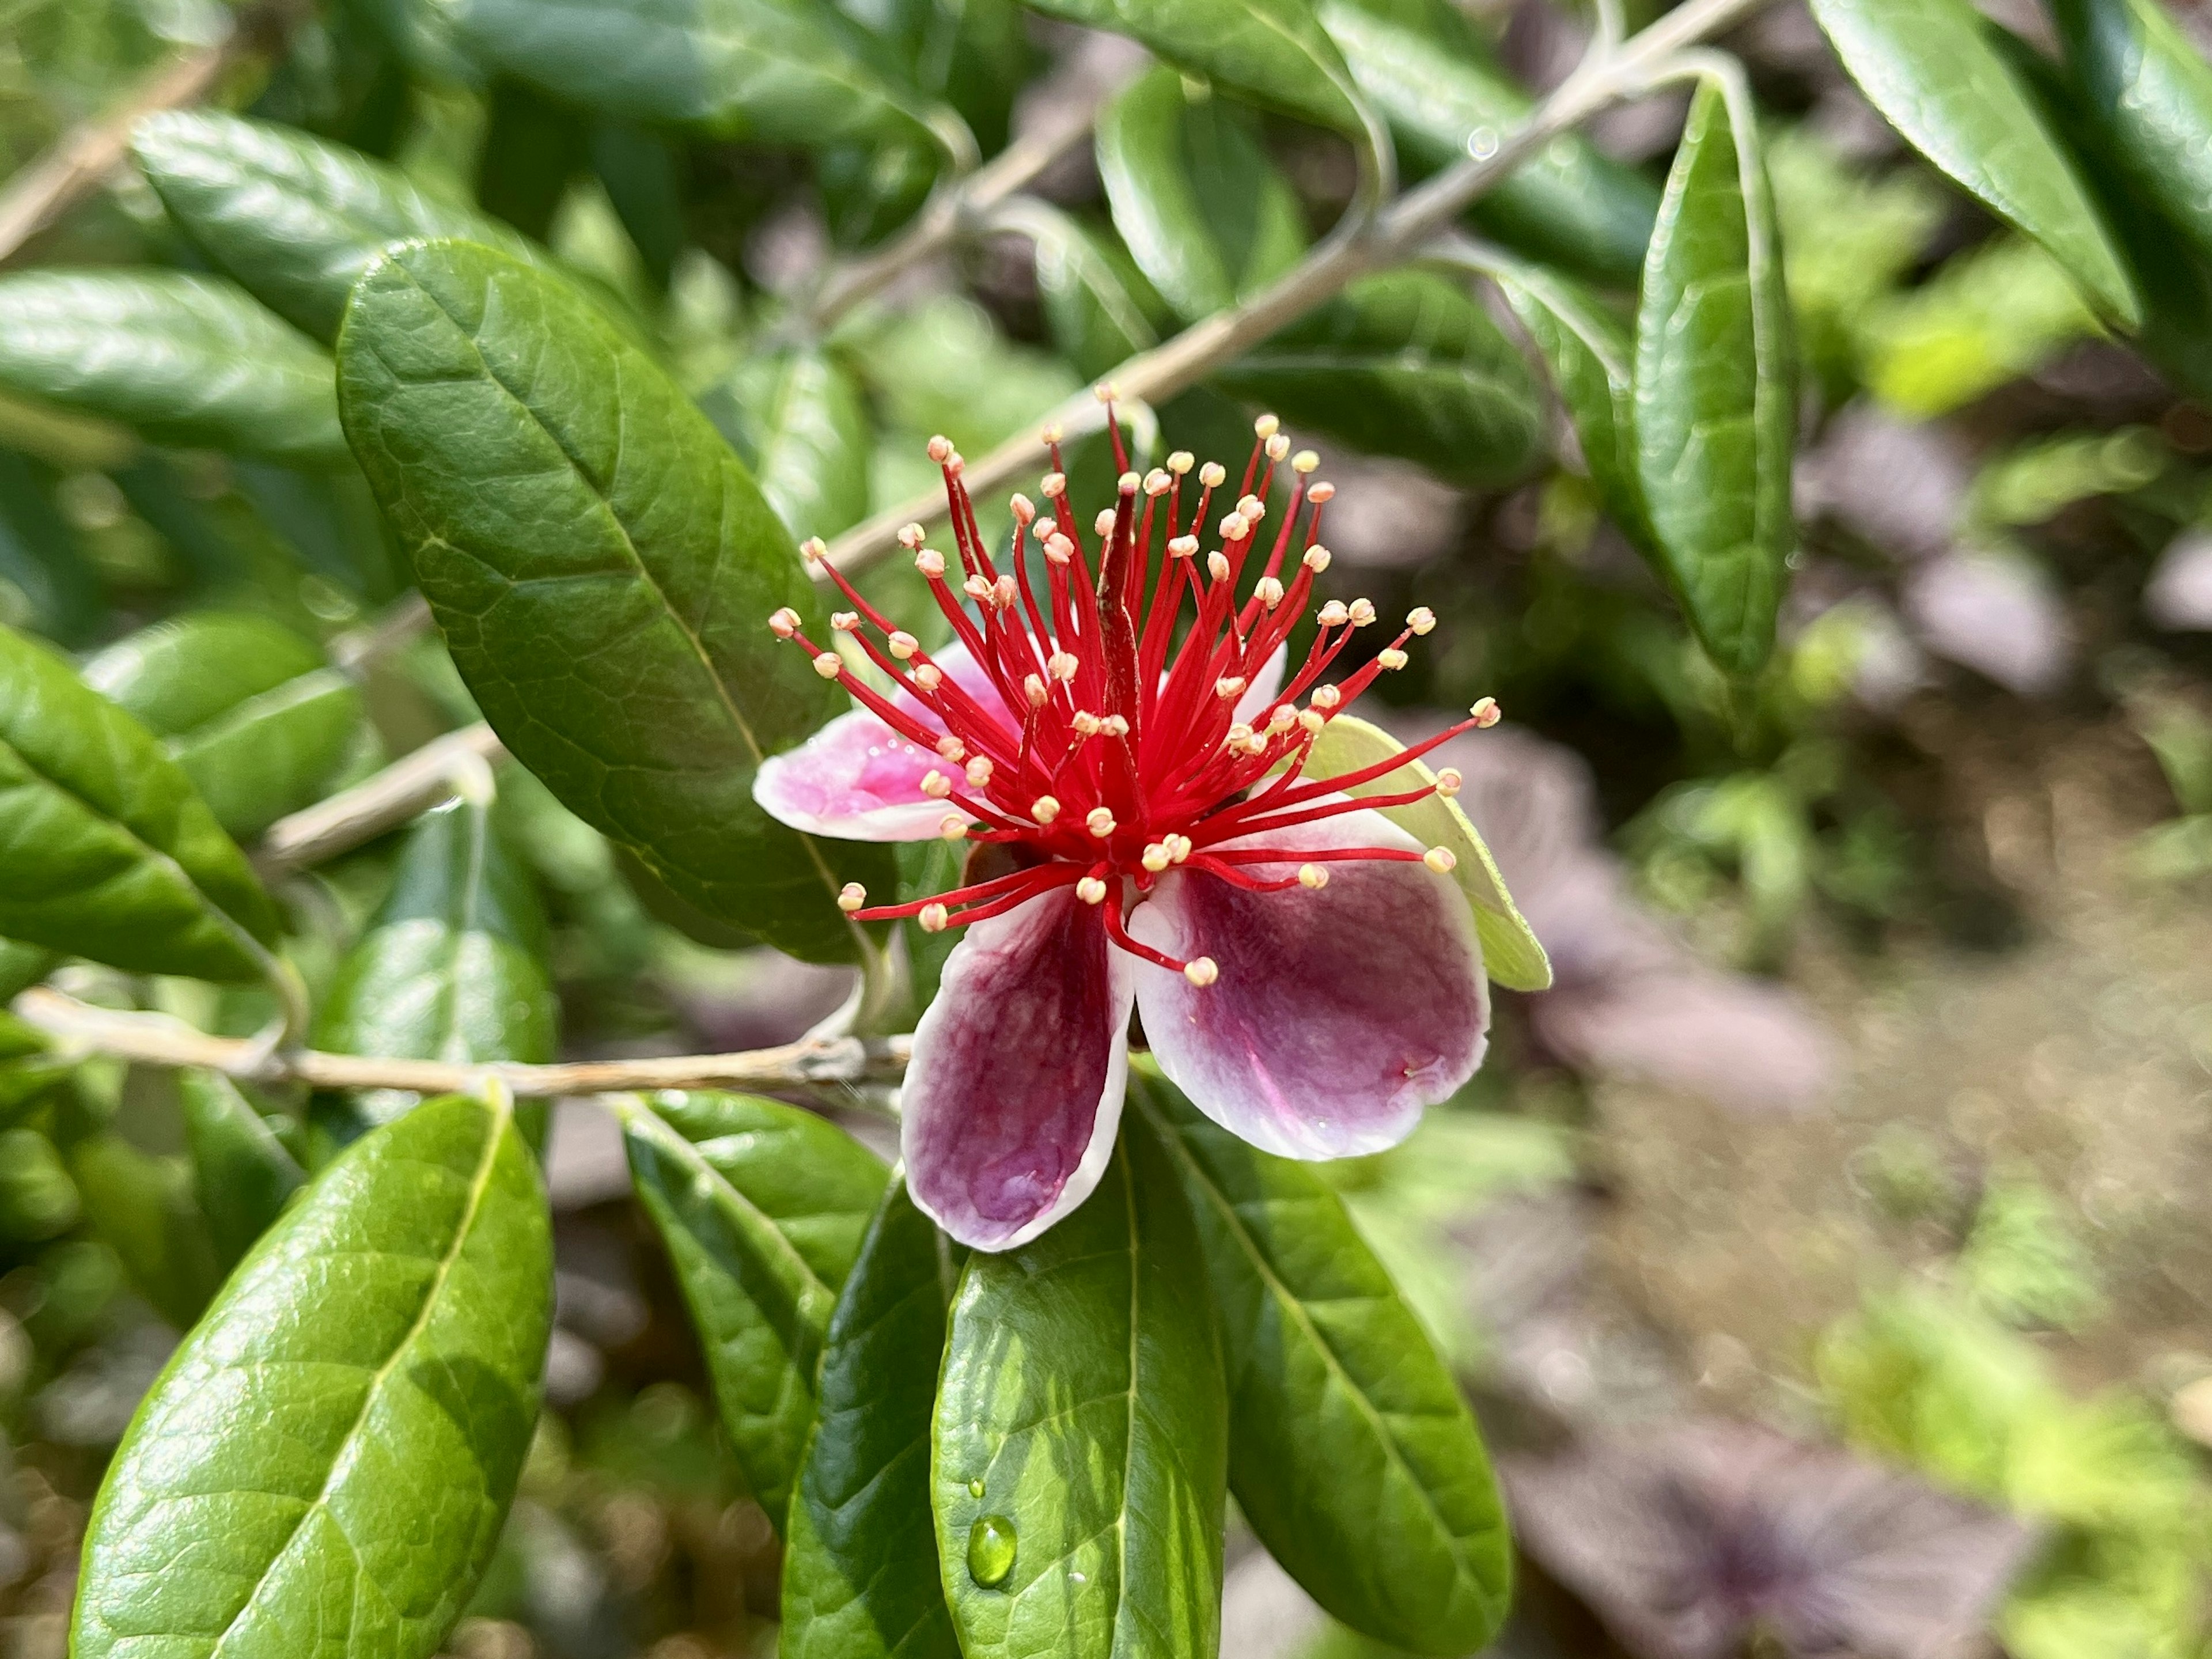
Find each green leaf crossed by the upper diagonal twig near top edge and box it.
[1320,0,1659,283]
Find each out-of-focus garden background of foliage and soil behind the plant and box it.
[0,0,2212,1659]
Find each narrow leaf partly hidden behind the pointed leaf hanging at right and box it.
[1498,266,1666,559]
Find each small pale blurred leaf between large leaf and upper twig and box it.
[701,347,874,540]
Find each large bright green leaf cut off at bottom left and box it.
[71,1095,553,1659]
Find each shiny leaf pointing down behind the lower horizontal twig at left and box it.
[314,801,560,1137]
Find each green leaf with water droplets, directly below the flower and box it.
[931,1119,1228,1659]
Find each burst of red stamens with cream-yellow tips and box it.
[767,387,1498,984]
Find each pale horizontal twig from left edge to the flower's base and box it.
[16,987,914,1099]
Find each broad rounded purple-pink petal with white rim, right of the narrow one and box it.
[1130,812,1491,1159]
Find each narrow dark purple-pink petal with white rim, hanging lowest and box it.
[900,887,1135,1250]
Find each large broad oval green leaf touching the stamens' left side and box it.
[336,241,892,960]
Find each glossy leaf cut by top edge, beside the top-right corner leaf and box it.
[1812,0,2141,323]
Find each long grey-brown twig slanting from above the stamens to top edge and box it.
[830,0,1767,571]
